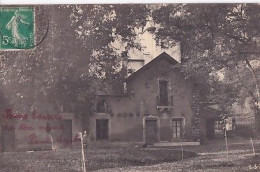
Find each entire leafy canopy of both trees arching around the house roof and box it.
[0,4,260,133]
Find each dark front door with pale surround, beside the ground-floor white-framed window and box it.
[145,120,157,144]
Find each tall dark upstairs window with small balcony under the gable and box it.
[159,80,168,106]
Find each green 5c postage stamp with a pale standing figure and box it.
[0,7,35,50]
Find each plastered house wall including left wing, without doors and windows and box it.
[92,56,198,141]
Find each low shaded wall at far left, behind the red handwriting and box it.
[1,109,81,151]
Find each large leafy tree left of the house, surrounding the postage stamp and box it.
[0,5,149,130]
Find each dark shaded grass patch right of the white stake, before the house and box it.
[87,148,197,170]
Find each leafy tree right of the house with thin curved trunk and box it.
[153,4,260,131]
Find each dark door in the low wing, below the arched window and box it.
[96,119,108,140]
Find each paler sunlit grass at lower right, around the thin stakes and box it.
[95,139,260,172]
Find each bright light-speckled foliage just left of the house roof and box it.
[69,4,150,93]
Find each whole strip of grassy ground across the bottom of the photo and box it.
[0,139,260,172]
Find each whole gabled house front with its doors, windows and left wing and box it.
[90,53,200,143]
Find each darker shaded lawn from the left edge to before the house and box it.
[0,143,196,172]
